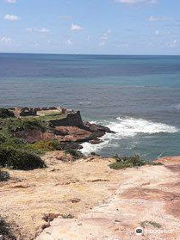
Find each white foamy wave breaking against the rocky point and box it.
[81,117,179,155]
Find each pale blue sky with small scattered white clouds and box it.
[0,0,180,55]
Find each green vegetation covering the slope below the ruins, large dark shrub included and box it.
[0,115,65,170]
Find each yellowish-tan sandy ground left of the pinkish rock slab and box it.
[0,152,121,240]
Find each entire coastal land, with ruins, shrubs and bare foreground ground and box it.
[0,108,180,240]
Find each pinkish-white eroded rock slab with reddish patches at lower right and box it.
[37,157,180,240]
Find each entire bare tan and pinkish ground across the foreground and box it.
[0,152,180,240]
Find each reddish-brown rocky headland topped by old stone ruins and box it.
[5,107,111,148]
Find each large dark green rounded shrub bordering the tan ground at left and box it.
[0,147,46,170]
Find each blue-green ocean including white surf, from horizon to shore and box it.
[0,54,180,160]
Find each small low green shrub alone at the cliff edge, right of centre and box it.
[109,155,147,169]
